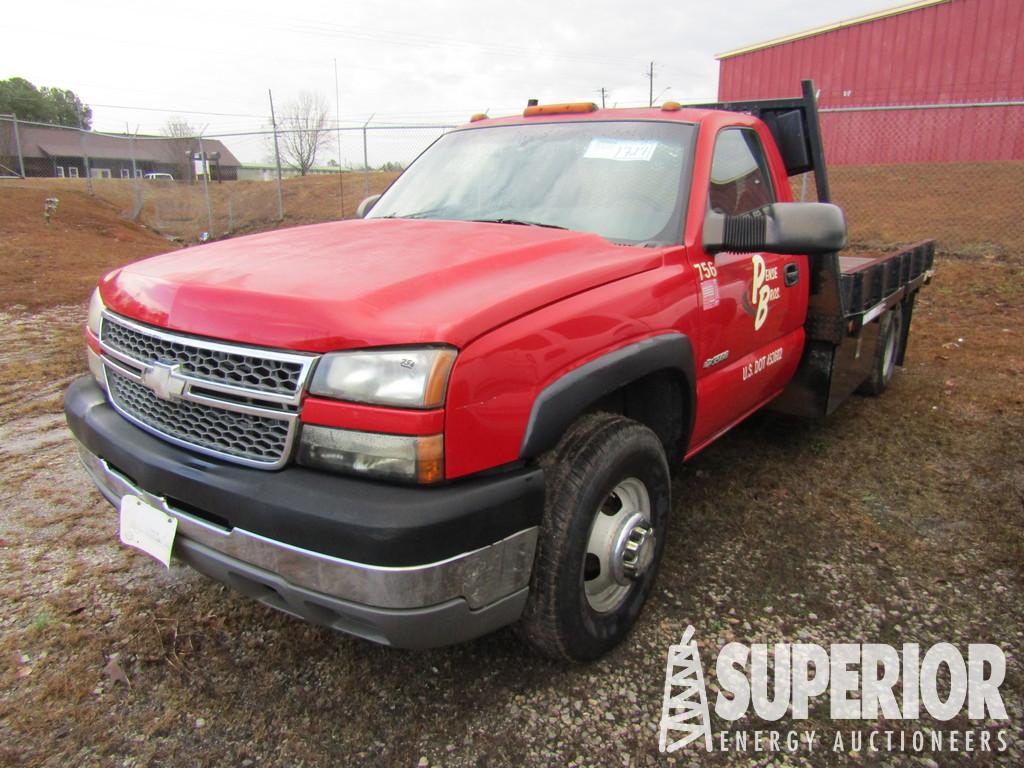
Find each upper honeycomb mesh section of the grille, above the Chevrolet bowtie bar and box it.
[101,316,303,395]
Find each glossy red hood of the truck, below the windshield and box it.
[100,219,663,352]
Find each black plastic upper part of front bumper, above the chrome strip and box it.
[65,377,544,566]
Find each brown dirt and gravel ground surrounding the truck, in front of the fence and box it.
[0,182,1024,767]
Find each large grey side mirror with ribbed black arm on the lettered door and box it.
[703,203,846,255]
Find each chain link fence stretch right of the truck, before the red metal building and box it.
[793,102,1024,259]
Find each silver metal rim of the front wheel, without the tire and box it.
[583,477,655,613]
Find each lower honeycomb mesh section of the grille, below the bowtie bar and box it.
[106,370,290,464]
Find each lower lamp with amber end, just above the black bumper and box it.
[299,424,444,483]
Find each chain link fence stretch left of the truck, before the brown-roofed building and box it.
[0,116,452,243]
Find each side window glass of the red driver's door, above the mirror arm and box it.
[708,128,775,215]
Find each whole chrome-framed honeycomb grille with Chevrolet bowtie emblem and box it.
[99,312,315,469]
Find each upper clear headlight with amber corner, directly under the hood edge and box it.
[309,347,456,409]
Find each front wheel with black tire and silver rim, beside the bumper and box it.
[519,414,671,662]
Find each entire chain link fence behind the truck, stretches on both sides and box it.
[0,102,1024,258]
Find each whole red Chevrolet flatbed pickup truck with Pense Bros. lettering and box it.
[59,83,933,659]
